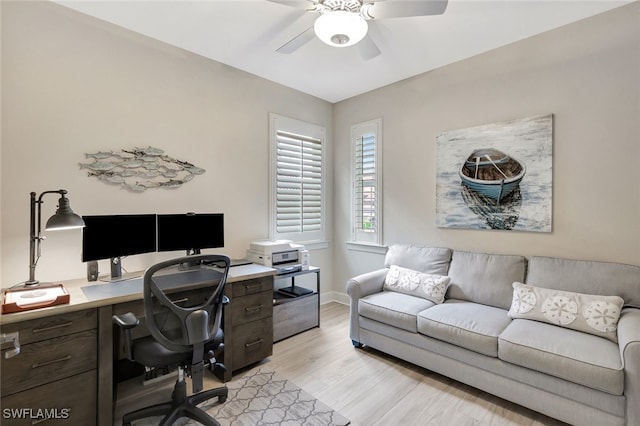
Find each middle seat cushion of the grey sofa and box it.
[418,299,511,357]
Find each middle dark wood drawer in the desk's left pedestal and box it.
[2,330,98,396]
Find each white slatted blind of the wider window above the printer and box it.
[276,130,322,234]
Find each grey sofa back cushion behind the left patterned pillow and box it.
[384,244,451,275]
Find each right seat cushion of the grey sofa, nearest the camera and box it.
[498,319,624,395]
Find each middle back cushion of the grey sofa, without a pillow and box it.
[447,250,527,310]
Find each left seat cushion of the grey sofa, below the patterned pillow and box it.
[358,291,435,333]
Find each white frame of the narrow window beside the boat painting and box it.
[350,118,383,247]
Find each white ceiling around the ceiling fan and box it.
[54,0,637,102]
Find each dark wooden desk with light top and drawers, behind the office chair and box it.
[0,264,275,426]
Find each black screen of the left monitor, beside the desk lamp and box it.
[82,214,156,262]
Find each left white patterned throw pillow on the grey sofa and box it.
[384,265,451,303]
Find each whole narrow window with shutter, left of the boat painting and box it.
[351,119,382,244]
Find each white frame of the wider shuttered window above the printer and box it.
[269,113,327,244]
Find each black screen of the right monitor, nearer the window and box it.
[158,213,224,253]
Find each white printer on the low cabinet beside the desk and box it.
[247,240,304,274]
